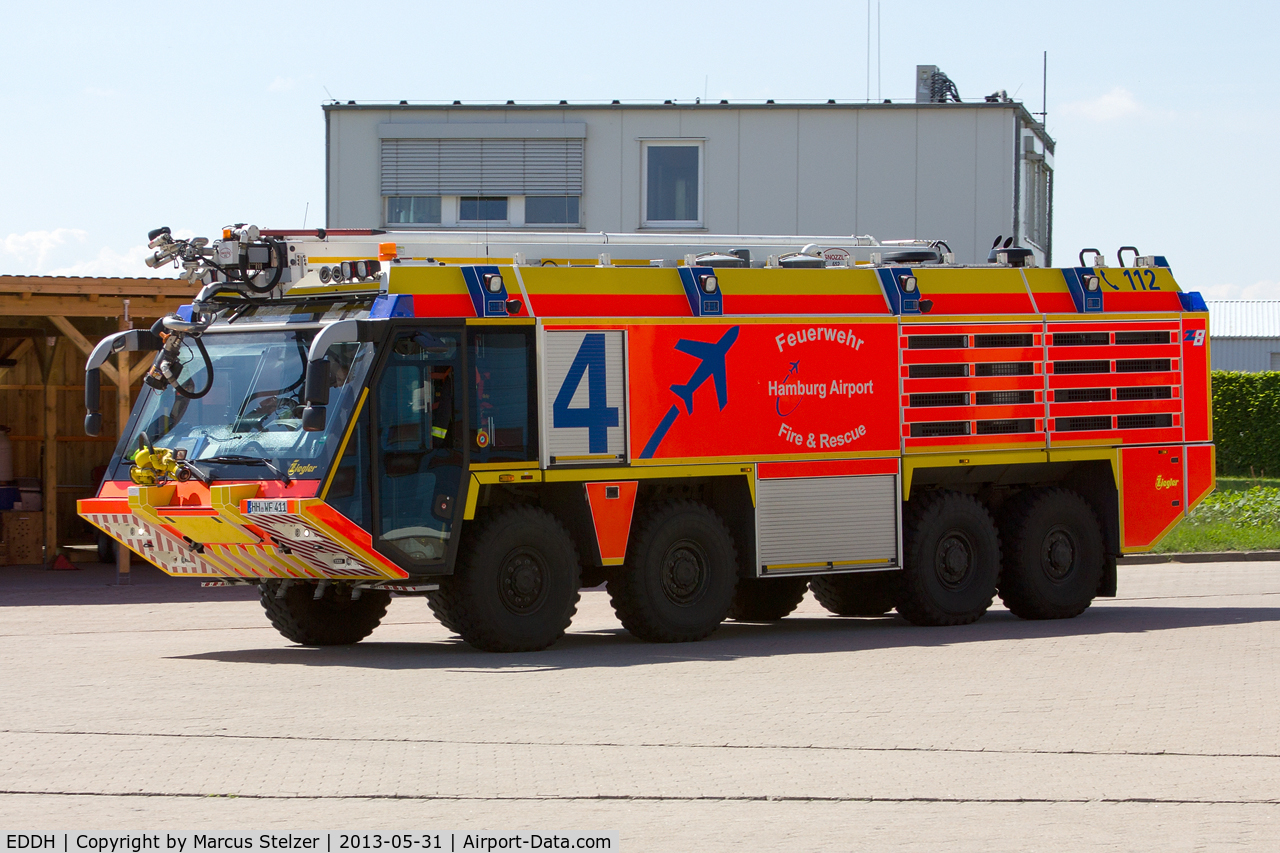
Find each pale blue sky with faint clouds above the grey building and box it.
[0,0,1280,298]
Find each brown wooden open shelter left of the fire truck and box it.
[0,275,198,571]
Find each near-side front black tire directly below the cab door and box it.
[433,506,580,652]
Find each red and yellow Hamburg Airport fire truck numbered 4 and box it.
[79,225,1213,652]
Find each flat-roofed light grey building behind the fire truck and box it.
[324,83,1053,264]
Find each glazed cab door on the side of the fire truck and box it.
[370,324,467,570]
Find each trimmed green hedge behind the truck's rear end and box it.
[1212,370,1280,476]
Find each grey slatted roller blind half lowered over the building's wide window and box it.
[381,138,582,196]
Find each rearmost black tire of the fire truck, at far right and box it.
[1000,488,1106,619]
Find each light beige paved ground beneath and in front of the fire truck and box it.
[0,562,1280,850]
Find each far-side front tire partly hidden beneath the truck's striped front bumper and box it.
[259,581,392,646]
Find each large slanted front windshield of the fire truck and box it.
[115,329,374,479]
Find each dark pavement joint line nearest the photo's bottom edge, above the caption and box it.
[0,789,1280,806]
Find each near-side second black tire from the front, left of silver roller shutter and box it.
[607,501,737,643]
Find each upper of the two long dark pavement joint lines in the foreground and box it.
[0,729,1280,758]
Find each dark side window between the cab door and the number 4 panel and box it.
[467,327,538,462]
